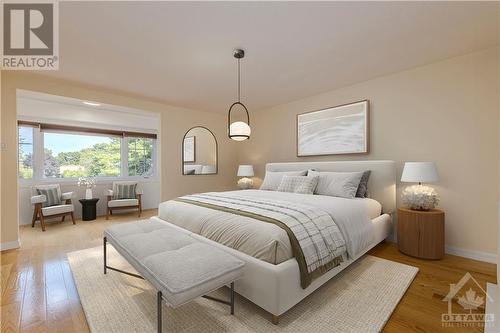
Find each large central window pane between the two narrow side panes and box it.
[43,132,121,178]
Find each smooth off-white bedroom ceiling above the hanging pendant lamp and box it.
[43,2,497,112]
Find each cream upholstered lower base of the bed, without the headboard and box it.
[152,214,392,316]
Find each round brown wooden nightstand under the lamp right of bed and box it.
[398,208,444,259]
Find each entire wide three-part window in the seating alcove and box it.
[18,121,157,181]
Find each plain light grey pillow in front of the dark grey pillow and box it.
[308,171,363,199]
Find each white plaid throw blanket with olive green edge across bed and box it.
[175,193,346,289]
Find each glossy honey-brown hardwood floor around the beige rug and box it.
[0,210,496,332]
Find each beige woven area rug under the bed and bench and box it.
[68,245,418,333]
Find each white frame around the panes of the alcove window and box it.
[16,124,159,186]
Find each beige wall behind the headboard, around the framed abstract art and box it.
[239,48,499,254]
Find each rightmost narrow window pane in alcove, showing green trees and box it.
[126,137,153,177]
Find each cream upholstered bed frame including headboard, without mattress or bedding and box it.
[153,161,396,324]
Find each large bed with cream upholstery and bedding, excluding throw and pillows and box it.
[155,161,396,323]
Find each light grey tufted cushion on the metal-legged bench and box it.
[104,220,245,307]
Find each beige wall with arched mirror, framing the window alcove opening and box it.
[0,71,237,244]
